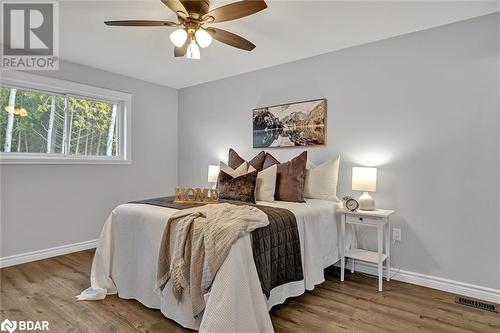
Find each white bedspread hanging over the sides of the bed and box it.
[79,199,353,333]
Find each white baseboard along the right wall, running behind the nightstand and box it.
[335,261,500,304]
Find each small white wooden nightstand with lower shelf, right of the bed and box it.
[337,208,394,291]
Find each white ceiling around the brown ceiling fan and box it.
[59,0,500,88]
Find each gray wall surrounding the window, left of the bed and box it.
[0,63,178,257]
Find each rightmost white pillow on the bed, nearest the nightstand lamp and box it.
[304,156,340,202]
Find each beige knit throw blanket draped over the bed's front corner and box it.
[156,203,269,317]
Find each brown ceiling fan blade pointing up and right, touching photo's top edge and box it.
[203,0,267,23]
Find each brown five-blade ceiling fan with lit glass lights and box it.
[104,0,267,59]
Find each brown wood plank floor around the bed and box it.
[0,250,500,333]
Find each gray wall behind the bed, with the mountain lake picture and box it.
[178,14,500,289]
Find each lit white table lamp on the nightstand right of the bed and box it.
[352,167,377,210]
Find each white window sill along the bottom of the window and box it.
[0,154,132,165]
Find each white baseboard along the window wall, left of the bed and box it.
[0,239,99,268]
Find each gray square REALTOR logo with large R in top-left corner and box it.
[0,1,59,70]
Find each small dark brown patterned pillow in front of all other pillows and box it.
[217,171,257,203]
